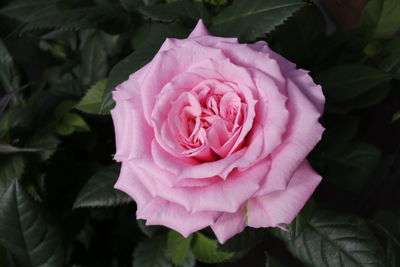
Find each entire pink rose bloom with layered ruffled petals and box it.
[111,21,324,243]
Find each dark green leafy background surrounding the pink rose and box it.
[0,0,400,267]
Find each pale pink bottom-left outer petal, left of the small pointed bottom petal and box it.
[137,198,221,237]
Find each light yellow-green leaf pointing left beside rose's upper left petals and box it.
[75,79,107,114]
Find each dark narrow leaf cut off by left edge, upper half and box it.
[0,40,20,105]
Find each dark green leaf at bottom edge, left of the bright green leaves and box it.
[133,235,172,267]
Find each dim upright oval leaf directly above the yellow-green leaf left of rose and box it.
[81,32,107,86]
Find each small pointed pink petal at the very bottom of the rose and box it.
[211,205,246,244]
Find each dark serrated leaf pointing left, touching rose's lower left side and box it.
[74,164,132,208]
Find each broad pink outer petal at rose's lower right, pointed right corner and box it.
[247,160,322,228]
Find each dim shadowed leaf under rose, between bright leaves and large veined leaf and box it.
[218,227,265,252]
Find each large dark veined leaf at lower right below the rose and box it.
[274,211,387,267]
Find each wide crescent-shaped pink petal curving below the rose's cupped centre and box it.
[130,155,269,213]
